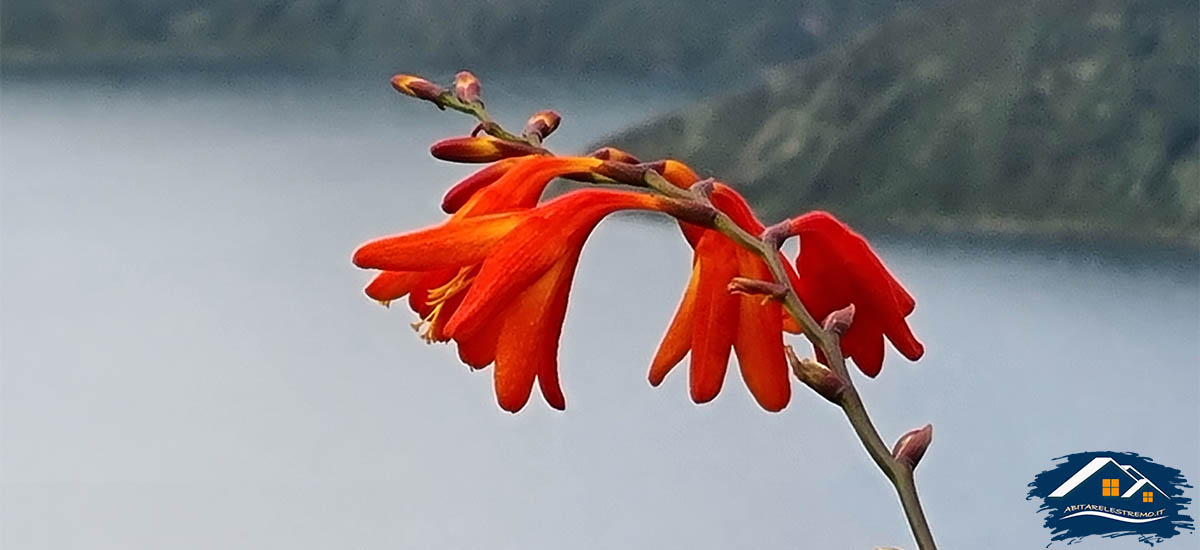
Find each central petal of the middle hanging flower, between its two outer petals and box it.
[689,232,738,403]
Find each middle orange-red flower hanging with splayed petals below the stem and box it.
[649,180,791,412]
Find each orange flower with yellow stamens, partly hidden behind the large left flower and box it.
[365,155,602,342]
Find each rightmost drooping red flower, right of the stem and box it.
[788,211,925,377]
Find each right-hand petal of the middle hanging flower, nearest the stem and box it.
[733,251,792,412]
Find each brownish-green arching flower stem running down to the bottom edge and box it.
[644,171,937,550]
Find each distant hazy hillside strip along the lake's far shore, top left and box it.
[0,0,926,76]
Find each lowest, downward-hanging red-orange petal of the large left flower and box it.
[494,250,578,412]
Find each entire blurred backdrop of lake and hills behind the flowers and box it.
[0,0,1200,549]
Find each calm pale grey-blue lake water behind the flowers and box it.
[0,76,1200,549]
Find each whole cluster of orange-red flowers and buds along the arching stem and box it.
[354,72,924,412]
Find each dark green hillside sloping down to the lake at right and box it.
[608,0,1200,246]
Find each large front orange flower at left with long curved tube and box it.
[354,190,668,412]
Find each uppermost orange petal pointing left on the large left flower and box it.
[354,214,522,271]
